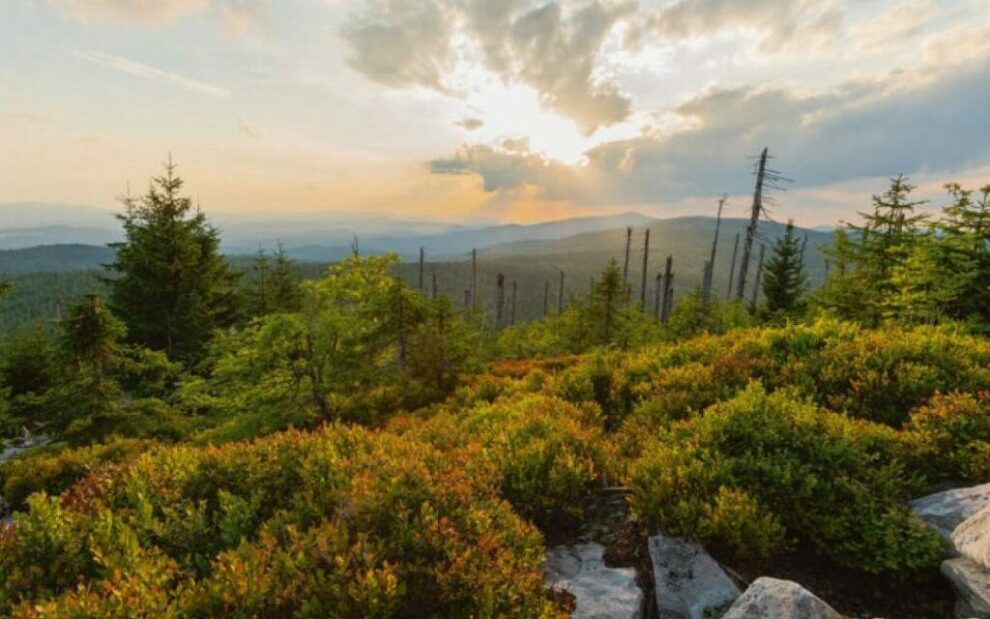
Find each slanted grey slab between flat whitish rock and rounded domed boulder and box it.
[649,535,739,619]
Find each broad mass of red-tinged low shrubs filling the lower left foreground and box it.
[0,426,562,617]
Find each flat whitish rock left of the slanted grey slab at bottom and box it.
[544,543,643,619]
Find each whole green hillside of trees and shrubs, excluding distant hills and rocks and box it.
[0,165,990,618]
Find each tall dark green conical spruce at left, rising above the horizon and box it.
[107,160,237,363]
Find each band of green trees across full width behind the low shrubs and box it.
[0,162,990,444]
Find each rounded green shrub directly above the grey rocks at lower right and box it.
[630,384,941,573]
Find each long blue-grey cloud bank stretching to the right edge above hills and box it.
[431,48,990,205]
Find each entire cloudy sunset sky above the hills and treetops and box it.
[0,0,990,225]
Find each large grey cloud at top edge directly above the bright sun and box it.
[342,0,637,134]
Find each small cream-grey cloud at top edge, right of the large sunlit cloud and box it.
[646,0,844,52]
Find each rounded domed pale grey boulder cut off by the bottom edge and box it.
[722,578,842,619]
